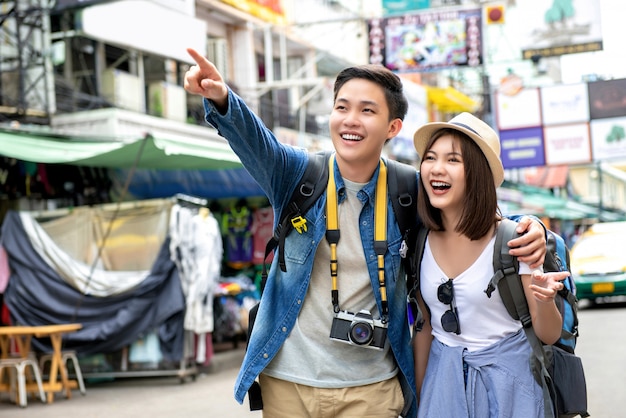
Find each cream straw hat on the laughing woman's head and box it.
[413,112,504,187]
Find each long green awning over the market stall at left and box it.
[0,128,242,170]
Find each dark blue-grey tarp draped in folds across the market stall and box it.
[1,211,185,361]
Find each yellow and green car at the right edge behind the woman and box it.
[570,222,626,301]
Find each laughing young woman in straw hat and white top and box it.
[414,113,567,418]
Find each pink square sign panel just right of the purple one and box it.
[543,123,591,165]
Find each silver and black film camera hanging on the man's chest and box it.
[330,309,387,350]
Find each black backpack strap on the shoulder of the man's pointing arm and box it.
[261,151,330,282]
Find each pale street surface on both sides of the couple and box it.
[0,300,626,418]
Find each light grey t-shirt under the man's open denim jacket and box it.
[263,179,397,388]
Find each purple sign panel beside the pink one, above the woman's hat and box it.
[500,127,545,169]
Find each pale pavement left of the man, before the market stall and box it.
[0,347,261,418]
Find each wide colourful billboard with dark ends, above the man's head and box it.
[368,9,483,72]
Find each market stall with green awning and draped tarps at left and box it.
[0,130,271,377]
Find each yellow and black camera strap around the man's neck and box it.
[326,155,389,322]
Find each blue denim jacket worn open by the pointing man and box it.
[204,92,417,417]
